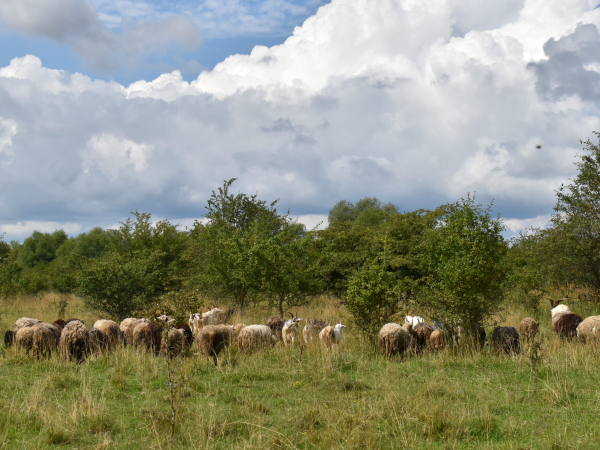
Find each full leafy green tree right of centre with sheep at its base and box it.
[419,196,508,337]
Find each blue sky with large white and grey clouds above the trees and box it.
[0,0,600,241]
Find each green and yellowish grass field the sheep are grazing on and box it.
[0,295,600,450]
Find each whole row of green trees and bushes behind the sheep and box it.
[0,135,600,340]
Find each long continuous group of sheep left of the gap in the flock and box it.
[4,308,345,364]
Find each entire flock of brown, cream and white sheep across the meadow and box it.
[4,299,600,364]
